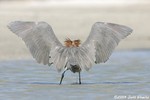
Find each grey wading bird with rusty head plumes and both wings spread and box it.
[7,21,133,84]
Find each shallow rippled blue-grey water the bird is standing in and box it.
[0,51,150,100]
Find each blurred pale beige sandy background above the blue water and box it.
[0,0,150,60]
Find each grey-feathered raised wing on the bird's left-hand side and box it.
[8,21,62,65]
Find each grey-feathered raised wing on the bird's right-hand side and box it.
[81,22,132,63]
